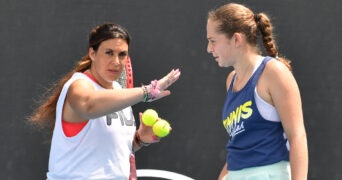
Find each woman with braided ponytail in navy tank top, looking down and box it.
[207,3,308,180]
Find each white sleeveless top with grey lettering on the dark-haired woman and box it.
[47,73,136,180]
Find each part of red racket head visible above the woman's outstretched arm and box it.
[117,57,134,88]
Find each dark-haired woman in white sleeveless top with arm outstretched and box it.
[30,23,181,180]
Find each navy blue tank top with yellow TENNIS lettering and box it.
[222,57,289,170]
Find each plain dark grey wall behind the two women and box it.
[0,0,342,180]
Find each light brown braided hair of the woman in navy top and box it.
[208,3,292,70]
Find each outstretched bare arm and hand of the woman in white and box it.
[63,69,181,122]
